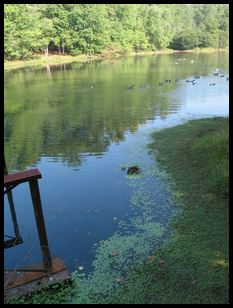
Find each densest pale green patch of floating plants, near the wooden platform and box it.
[75,221,165,303]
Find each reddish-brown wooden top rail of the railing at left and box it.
[4,168,42,187]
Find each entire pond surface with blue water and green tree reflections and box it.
[4,52,229,273]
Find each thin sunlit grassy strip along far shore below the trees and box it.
[4,48,228,70]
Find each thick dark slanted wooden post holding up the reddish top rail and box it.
[29,179,52,271]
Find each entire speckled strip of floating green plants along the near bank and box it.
[72,130,177,304]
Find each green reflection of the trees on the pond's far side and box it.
[4,53,228,170]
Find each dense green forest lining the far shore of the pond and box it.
[4,4,229,60]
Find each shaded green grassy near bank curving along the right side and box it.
[6,118,229,304]
